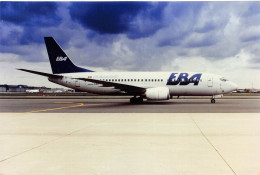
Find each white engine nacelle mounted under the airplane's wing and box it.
[145,87,170,100]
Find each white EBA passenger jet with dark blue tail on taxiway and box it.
[18,37,237,104]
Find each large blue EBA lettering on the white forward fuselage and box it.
[167,73,201,86]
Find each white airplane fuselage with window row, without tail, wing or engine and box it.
[49,72,237,96]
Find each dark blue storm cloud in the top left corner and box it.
[1,2,61,27]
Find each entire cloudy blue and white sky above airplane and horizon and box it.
[0,1,260,89]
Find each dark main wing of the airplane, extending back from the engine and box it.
[73,78,146,95]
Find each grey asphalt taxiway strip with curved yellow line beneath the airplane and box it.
[0,97,260,113]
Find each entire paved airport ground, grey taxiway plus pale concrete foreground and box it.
[0,97,260,175]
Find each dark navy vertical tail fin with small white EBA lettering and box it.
[44,37,93,74]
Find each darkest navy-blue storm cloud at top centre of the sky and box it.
[70,2,149,34]
